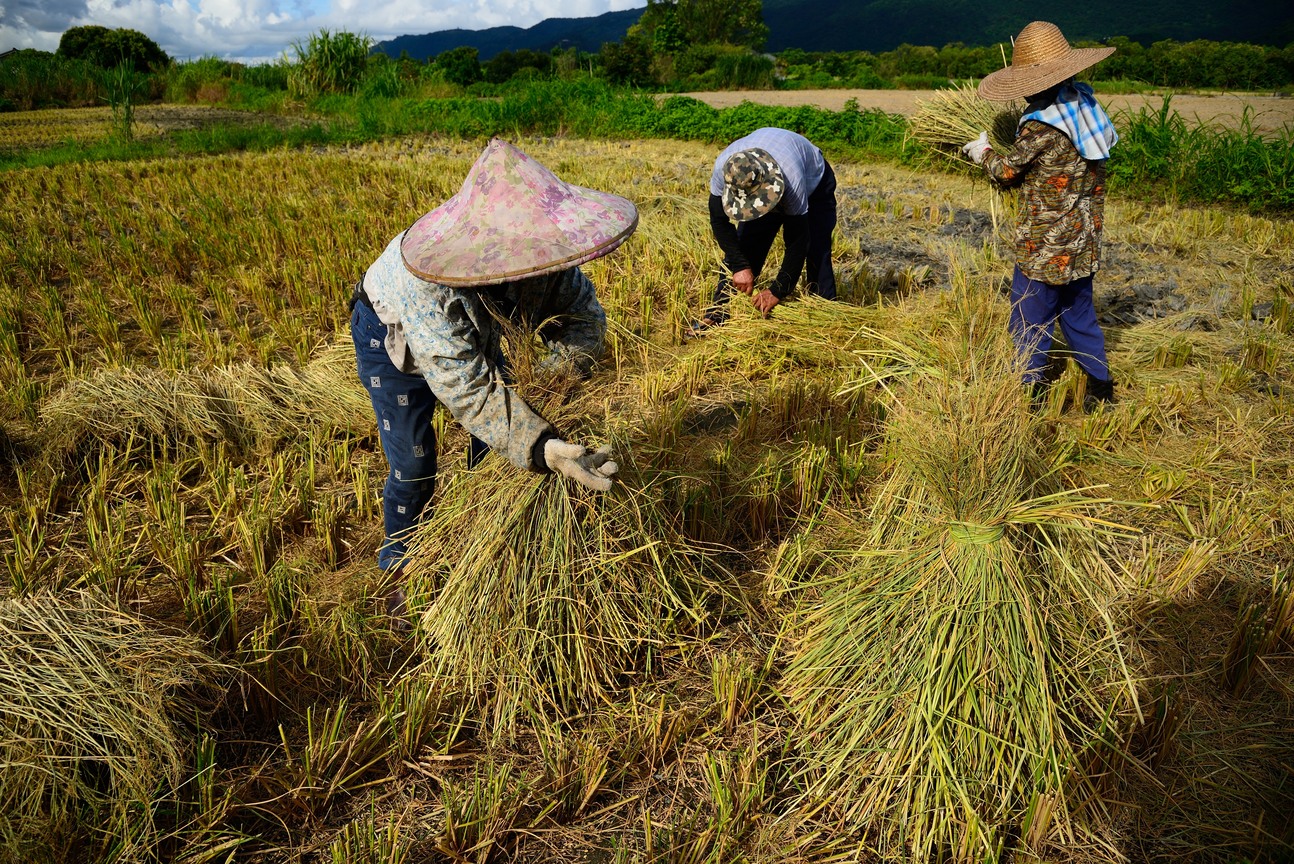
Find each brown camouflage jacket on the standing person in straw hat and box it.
[983,120,1105,285]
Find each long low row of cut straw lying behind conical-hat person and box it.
[40,339,373,454]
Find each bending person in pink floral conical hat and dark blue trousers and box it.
[351,138,638,626]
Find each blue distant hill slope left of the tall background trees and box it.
[375,9,643,61]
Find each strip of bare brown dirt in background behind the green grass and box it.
[683,91,1294,135]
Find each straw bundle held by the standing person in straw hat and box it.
[907,84,1024,172]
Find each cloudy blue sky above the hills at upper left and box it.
[0,0,646,62]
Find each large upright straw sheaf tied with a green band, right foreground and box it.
[775,328,1132,860]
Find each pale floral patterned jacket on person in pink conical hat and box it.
[364,234,607,471]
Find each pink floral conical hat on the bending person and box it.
[400,138,638,286]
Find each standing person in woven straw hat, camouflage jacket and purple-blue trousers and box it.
[963,21,1118,411]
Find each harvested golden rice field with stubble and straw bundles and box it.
[0,136,1294,864]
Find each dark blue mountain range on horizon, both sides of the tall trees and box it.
[377,0,1294,59]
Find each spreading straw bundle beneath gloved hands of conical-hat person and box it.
[405,411,731,731]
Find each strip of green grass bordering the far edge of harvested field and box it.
[0,79,1294,213]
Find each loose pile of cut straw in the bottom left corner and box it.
[0,592,214,861]
